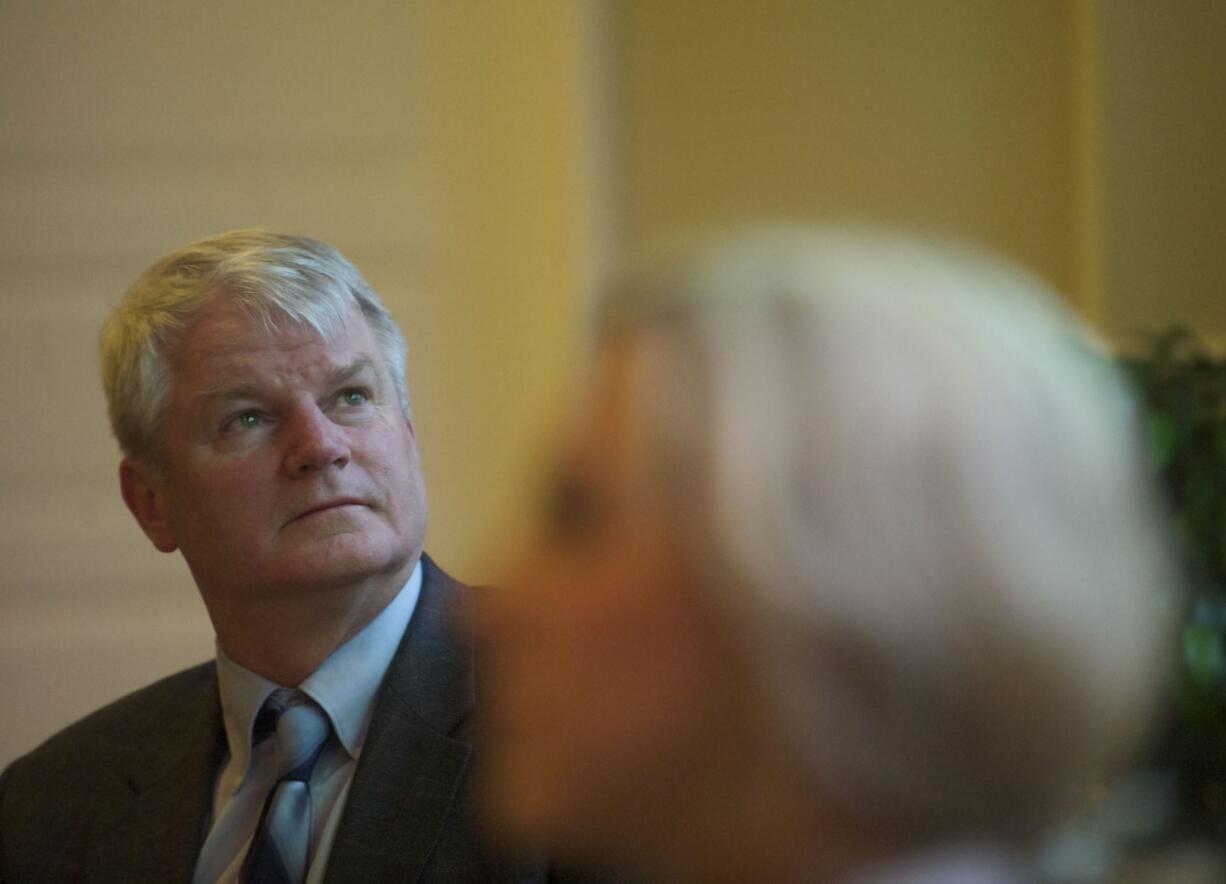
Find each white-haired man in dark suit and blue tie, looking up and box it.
[0,231,610,884]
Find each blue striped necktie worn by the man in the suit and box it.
[239,688,332,884]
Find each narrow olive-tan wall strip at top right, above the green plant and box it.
[1098,0,1226,345]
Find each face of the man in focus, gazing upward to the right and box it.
[124,297,425,606]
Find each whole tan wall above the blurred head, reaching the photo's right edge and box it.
[612,0,1226,342]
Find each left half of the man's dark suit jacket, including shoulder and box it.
[0,662,222,883]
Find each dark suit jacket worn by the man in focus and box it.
[0,557,603,884]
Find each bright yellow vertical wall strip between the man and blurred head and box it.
[413,0,597,579]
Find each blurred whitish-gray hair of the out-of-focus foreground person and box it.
[600,229,1178,835]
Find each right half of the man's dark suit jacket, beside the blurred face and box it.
[325,555,473,884]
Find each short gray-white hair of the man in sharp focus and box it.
[99,229,412,463]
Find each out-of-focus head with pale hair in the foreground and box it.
[485,231,1173,882]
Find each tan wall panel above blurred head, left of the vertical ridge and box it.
[617,0,1076,297]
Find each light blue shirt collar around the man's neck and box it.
[217,560,422,791]
